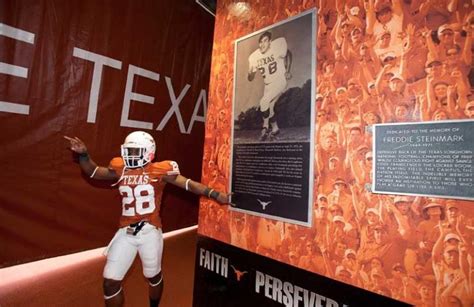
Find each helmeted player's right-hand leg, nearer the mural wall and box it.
[138,224,164,307]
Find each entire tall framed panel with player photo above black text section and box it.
[231,10,316,225]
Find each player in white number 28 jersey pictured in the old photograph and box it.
[247,31,292,141]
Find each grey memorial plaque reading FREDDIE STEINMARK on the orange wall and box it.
[372,120,474,200]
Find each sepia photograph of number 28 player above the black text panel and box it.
[233,9,313,143]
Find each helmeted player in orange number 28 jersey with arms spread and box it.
[64,131,230,306]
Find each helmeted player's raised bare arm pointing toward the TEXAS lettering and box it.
[64,136,119,180]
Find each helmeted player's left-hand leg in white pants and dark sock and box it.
[103,228,137,307]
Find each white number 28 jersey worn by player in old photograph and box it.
[249,37,288,84]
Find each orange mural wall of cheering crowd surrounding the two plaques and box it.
[199,0,474,306]
